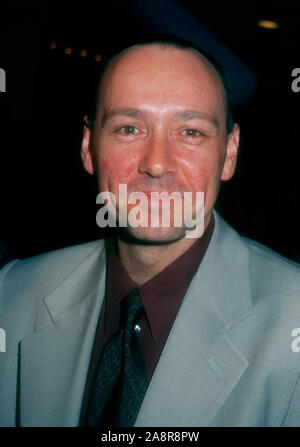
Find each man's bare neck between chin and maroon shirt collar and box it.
[117,214,212,286]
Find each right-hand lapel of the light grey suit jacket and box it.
[135,214,251,426]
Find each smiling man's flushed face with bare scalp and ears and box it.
[82,45,239,242]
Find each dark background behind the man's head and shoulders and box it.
[0,0,300,262]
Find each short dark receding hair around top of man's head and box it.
[88,34,234,134]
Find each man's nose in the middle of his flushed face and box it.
[139,135,176,178]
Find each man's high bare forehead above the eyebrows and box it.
[98,44,225,120]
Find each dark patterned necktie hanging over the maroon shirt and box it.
[85,289,147,427]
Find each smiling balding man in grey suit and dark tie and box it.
[0,36,300,426]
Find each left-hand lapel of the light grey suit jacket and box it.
[20,244,105,426]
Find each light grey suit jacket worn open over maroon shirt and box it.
[0,213,300,427]
